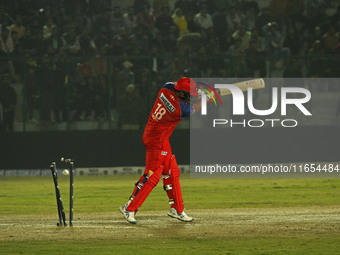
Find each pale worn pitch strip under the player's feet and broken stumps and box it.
[0,206,340,241]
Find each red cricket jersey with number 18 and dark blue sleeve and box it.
[143,82,194,146]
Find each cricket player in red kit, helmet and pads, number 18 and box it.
[119,77,200,224]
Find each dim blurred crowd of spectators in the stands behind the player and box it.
[0,0,340,129]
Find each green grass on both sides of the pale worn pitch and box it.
[0,175,340,254]
